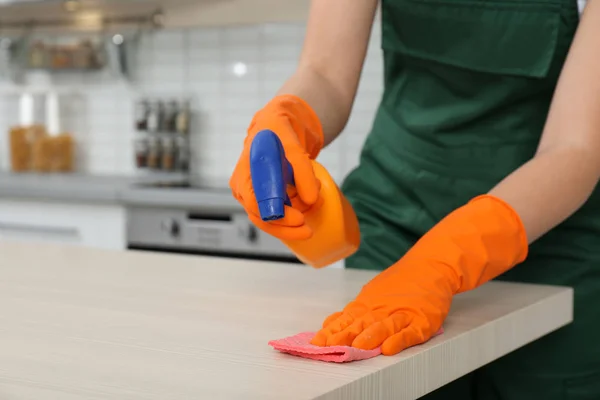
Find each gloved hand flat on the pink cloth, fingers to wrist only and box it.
[312,259,452,355]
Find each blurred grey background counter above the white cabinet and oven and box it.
[0,172,241,211]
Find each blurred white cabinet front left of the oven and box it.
[0,199,126,249]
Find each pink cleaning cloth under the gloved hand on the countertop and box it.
[269,329,443,363]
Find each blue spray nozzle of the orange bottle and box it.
[250,130,294,221]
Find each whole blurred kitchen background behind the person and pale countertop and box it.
[0,0,383,268]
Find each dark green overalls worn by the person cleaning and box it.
[343,0,600,400]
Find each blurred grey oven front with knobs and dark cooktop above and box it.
[127,179,299,263]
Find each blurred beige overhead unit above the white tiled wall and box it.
[0,0,310,31]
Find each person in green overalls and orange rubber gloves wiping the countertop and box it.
[230,0,600,400]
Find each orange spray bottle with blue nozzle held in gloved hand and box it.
[250,130,360,268]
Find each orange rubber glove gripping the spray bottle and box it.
[229,95,324,240]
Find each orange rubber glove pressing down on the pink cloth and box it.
[312,195,528,355]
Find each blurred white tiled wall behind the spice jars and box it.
[0,20,383,186]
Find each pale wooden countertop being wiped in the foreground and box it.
[0,243,573,400]
